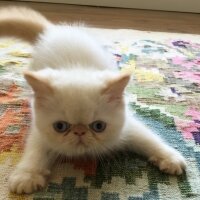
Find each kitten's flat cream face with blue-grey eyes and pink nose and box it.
[26,69,128,156]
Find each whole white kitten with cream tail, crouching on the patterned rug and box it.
[0,8,186,194]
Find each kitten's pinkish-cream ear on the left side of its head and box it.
[24,71,53,97]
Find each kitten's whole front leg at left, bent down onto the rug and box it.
[9,132,54,194]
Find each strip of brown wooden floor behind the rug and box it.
[0,1,200,34]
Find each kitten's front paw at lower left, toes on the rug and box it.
[9,169,50,194]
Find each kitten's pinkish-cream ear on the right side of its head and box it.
[103,73,131,102]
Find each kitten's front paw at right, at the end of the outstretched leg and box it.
[149,150,186,175]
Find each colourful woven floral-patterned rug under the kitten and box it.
[0,29,200,200]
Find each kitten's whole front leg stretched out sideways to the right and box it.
[124,119,186,175]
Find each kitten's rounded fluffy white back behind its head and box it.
[32,25,114,70]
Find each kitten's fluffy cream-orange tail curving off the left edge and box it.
[0,7,51,43]
